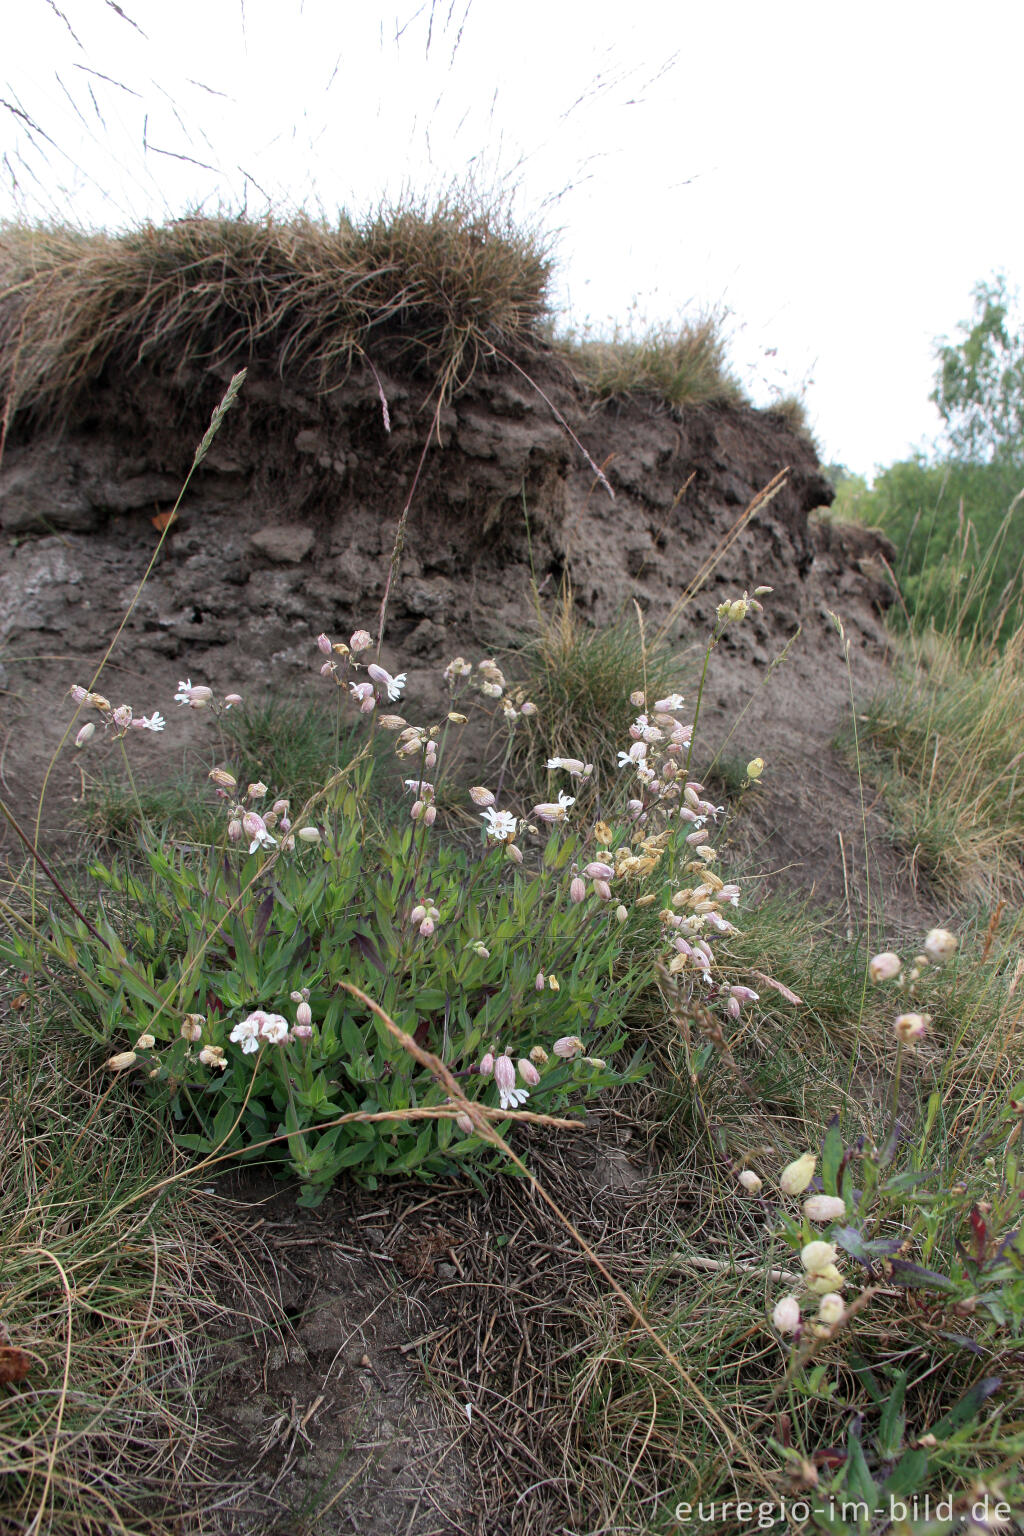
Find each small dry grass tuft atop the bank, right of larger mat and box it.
[557,315,743,407]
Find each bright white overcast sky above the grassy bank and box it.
[0,0,1024,473]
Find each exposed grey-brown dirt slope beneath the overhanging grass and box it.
[0,358,900,899]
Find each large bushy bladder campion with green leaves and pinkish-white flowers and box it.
[14,605,767,1204]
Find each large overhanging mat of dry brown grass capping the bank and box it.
[0,194,551,430]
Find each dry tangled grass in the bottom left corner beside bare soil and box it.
[0,998,280,1536]
